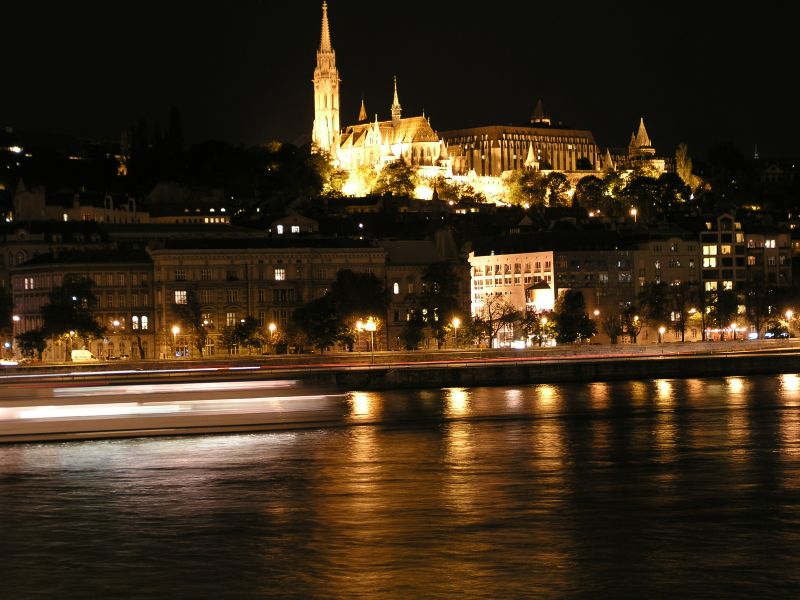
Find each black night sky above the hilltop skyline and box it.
[0,0,800,157]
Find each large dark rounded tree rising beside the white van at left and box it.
[41,275,105,361]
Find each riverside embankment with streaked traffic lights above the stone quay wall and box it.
[0,339,800,391]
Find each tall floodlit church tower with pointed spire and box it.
[311,0,339,158]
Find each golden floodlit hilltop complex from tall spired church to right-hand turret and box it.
[312,1,664,200]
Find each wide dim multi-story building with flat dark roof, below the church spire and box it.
[148,238,387,357]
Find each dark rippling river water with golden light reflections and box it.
[0,375,800,599]
